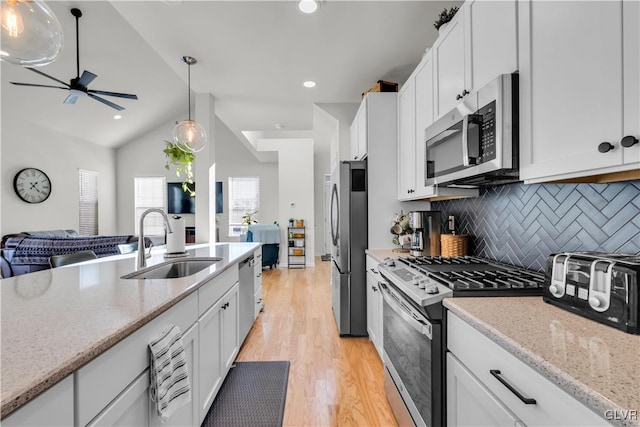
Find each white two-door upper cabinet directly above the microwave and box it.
[433,0,518,119]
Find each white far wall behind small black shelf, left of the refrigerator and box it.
[257,138,315,266]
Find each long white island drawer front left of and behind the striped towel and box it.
[75,293,198,425]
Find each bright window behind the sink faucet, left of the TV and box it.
[134,176,167,237]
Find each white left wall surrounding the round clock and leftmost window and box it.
[0,118,119,235]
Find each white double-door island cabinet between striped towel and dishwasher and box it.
[197,283,239,425]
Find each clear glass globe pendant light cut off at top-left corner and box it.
[0,0,62,67]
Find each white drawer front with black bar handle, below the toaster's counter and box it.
[447,312,610,426]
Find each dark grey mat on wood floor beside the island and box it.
[202,361,290,427]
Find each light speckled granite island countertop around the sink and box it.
[0,243,261,418]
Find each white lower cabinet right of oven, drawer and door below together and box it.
[447,312,610,426]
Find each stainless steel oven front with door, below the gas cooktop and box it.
[380,283,443,426]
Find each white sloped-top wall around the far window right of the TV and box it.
[215,119,278,241]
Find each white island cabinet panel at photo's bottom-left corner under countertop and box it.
[2,375,73,427]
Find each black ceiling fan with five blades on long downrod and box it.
[11,8,138,111]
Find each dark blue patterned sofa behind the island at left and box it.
[0,230,151,278]
